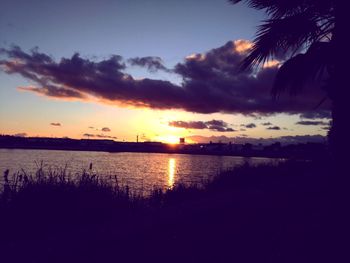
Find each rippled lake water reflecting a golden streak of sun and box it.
[0,149,278,195]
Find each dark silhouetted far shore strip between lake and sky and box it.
[0,135,328,159]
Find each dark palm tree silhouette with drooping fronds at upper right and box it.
[230,0,347,160]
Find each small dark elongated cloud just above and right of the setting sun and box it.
[169,120,235,132]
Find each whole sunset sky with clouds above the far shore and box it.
[0,0,330,142]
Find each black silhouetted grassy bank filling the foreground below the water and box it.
[0,161,334,262]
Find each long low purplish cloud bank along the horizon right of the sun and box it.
[186,134,326,145]
